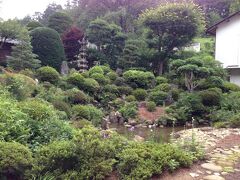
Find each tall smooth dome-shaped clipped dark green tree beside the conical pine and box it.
[30,27,65,71]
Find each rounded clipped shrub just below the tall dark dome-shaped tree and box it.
[36,66,60,84]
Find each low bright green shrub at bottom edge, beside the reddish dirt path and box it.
[118,143,192,179]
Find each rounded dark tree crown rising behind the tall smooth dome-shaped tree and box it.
[48,12,72,34]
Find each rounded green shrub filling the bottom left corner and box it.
[0,142,33,179]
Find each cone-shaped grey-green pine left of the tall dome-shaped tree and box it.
[7,31,41,71]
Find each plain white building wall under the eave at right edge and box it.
[216,15,240,68]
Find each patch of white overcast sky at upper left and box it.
[0,0,67,20]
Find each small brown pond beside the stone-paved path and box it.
[110,124,189,143]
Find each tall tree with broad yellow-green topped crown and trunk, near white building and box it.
[140,2,204,75]
